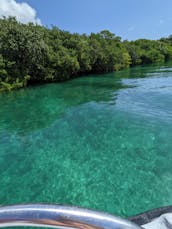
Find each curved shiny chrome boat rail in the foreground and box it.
[0,204,141,229]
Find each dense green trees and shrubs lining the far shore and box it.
[0,18,172,91]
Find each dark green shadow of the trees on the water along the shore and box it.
[0,64,172,134]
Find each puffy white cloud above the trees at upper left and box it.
[0,0,41,24]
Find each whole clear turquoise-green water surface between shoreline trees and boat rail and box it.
[0,65,172,216]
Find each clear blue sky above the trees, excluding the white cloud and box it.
[5,0,172,40]
